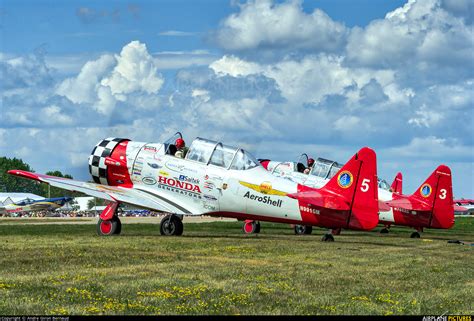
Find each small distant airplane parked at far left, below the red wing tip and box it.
[0,197,72,214]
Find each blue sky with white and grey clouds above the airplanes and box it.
[0,0,474,198]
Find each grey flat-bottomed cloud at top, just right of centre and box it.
[215,0,346,51]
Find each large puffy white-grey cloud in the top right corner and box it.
[346,0,474,75]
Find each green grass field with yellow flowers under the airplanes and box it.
[0,218,474,315]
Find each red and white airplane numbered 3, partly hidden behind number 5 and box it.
[260,154,455,238]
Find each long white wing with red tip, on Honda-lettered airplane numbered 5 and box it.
[8,170,191,214]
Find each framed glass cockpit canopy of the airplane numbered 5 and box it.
[186,137,260,170]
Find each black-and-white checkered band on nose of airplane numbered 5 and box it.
[89,137,125,185]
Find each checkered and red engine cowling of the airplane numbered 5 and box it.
[89,138,132,187]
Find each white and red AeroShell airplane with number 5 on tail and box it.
[8,132,378,241]
